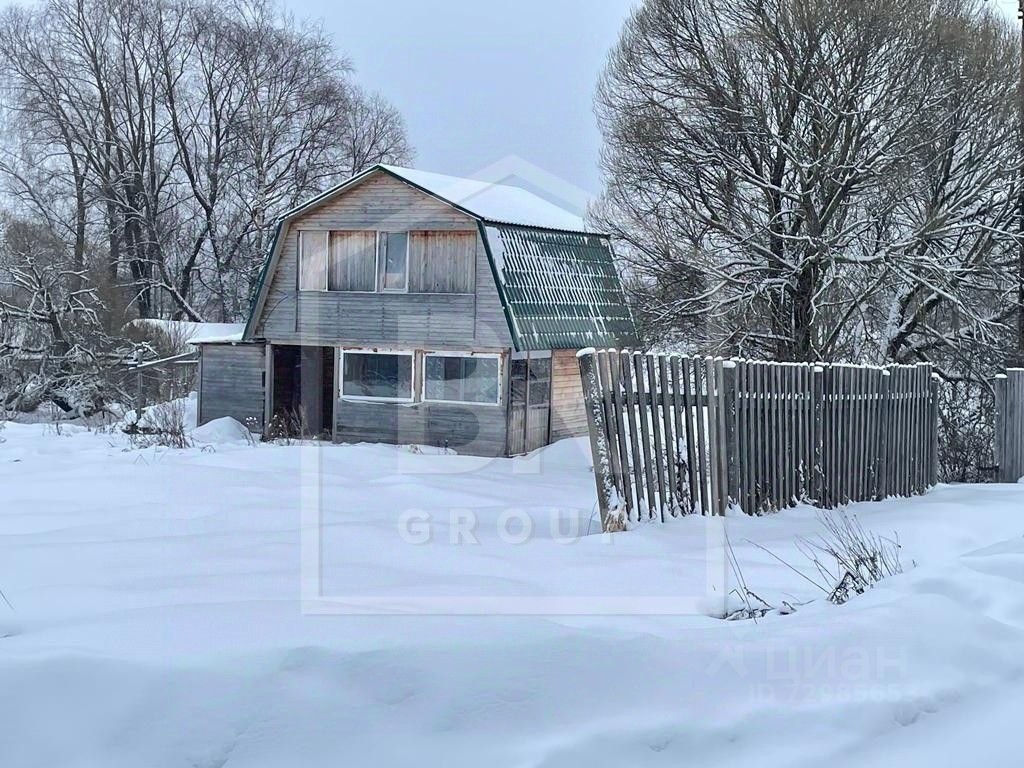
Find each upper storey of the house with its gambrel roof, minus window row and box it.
[245,166,638,351]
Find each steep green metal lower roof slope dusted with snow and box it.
[480,222,639,351]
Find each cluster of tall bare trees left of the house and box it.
[0,0,412,415]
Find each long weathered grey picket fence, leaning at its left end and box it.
[579,349,938,530]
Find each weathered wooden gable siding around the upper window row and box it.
[254,175,512,349]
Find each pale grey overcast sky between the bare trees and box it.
[285,0,634,193]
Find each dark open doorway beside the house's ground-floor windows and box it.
[270,345,335,437]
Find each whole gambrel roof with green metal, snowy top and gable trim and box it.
[245,165,638,351]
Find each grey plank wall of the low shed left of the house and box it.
[199,344,266,426]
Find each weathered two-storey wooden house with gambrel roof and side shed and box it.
[199,166,637,456]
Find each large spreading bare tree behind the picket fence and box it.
[596,0,1020,370]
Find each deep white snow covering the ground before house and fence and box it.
[0,415,1024,768]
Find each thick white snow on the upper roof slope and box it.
[380,165,588,232]
